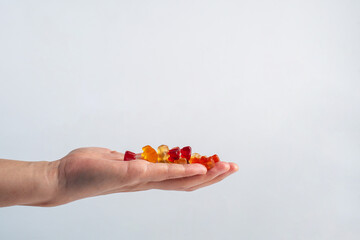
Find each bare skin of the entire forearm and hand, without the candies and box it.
[0,147,238,207]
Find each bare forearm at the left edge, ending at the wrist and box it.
[0,159,59,207]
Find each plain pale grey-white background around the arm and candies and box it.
[0,0,360,240]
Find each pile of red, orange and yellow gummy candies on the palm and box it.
[124,145,220,169]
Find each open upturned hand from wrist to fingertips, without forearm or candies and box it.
[51,147,238,205]
